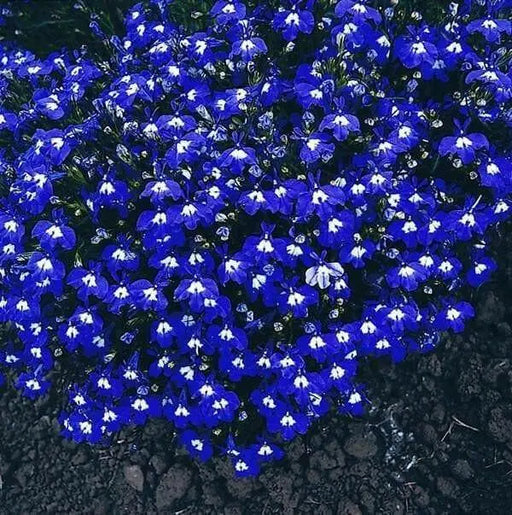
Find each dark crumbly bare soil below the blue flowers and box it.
[0,245,512,515]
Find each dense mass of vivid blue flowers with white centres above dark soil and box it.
[0,0,512,476]
